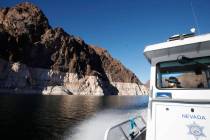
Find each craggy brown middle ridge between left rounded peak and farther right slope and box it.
[39,28,106,80]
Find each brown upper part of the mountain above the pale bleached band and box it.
[0,2,141,93]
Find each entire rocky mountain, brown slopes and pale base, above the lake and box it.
[0,2,148,95]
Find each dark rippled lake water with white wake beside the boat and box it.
[0,95,148,140]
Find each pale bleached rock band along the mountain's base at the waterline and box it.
[0,59,147,96]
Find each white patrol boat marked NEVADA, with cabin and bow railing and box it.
[104,33,210,140]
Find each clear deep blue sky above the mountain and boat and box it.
[0,0,210,83]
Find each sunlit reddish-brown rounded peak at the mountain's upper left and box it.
[0,3,50,43]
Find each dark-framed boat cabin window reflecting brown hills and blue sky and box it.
[156,57,210,89]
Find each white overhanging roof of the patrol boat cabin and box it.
[144,33,210,63]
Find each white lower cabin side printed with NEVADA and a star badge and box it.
[152,102,210,140]
